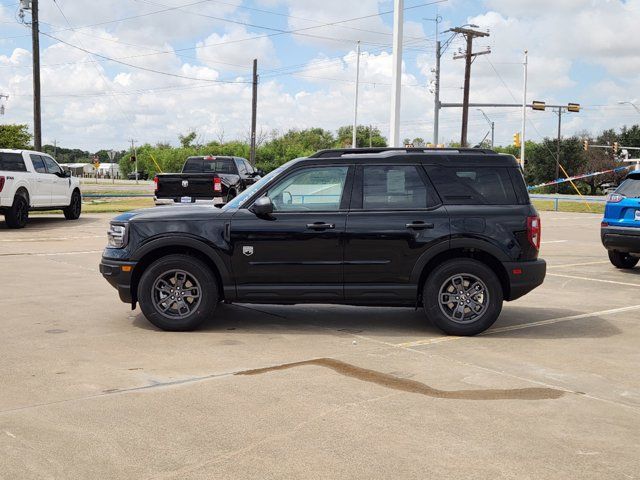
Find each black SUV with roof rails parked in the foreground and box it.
[100,149,546,335]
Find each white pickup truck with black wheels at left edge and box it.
[0,149,82,228]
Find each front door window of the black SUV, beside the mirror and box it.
[267,167,349,212]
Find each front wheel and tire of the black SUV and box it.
[138,254,218,332]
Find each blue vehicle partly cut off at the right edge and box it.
[600,170,640,268]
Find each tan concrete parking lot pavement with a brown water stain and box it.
[0,212,640,479]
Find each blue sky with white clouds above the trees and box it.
[0,0,640,152]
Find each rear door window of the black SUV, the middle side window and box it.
[362,165,428,210]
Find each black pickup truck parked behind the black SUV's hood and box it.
[154,155,261,205]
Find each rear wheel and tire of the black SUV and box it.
[422,258,504,336]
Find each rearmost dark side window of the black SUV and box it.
[428,166,518,205]
